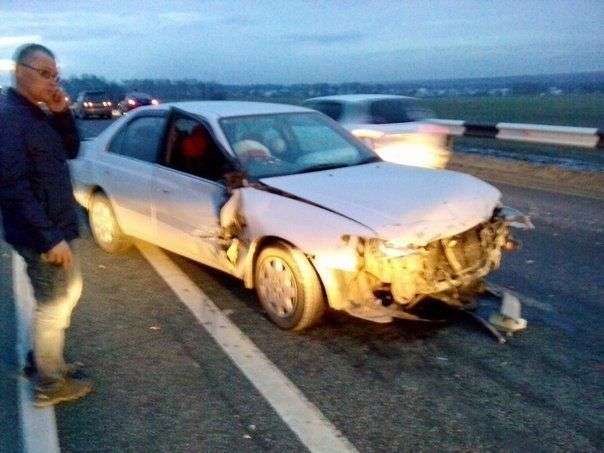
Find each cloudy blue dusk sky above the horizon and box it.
[0,0,604,84]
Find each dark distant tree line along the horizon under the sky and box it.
[64,71,604,102]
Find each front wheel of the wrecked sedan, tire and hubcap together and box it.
[254,243,327,331]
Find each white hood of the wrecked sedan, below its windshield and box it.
[262,162,501,245]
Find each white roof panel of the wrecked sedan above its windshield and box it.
[161,101,313,118]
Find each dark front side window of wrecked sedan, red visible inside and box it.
[160,117,229,181]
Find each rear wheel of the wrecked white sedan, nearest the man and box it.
[88,192,132,253]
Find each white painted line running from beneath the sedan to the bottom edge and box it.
[137,242,357,452]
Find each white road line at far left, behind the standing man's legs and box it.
[12,252,61,453]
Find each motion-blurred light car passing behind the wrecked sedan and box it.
[302,94,452,168]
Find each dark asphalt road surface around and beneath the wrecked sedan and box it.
[0,121,604,452]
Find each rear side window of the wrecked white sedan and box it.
[116,116,166,162]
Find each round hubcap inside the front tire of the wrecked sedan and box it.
[258,256,298,318]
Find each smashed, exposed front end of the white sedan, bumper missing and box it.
[347,219,517,320]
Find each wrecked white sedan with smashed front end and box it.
[72,101,531,330]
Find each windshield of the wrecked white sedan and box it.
[220,113,379,178]
